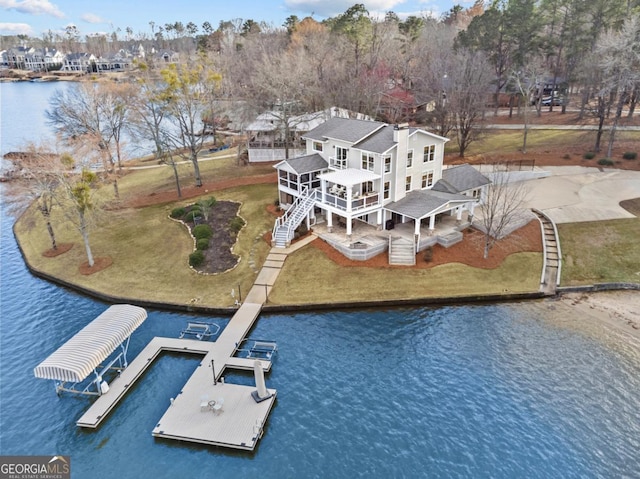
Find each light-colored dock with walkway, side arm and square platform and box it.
[76,238,312,450]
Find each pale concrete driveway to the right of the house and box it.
[527,166,640,223]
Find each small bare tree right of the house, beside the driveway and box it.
[476,165,528,259]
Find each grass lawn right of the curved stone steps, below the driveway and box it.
[558,218,640,286]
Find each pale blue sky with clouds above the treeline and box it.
[0,0,473,37]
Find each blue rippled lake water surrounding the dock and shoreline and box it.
[0,83,640,479]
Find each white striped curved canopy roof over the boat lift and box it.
[33,304,147,383]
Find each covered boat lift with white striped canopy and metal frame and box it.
[33,304,147,396]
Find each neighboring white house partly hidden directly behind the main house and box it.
[245,107,370,163]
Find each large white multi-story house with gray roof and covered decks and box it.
[272,118,489,259]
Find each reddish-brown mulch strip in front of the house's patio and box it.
[311,220,542,269]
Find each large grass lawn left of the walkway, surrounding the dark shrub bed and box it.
[16,182,276,307]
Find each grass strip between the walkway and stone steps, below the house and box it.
[269,247,542,305]
